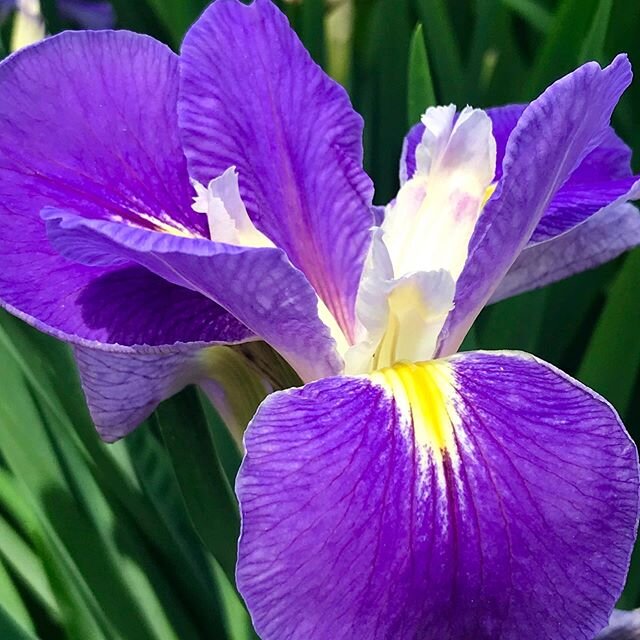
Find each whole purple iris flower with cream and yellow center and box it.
[0,0,640,640]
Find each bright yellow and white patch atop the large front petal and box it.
[369,361,455,456]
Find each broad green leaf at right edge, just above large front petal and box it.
[578,249,640,415]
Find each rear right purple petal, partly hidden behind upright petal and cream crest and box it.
[400,92,640,302]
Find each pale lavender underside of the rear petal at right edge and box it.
[490,204,640,302]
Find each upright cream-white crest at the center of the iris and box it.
[345,105,496,373]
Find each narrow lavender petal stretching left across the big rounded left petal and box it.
[42,209,341,380]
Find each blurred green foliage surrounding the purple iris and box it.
[0,0,640,640]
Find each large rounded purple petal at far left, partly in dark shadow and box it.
[0,32,229,348]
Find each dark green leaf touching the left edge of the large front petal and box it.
[155,387,240,584]
